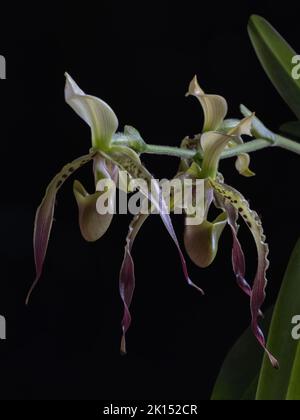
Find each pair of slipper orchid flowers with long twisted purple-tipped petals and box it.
[27,74,278,367]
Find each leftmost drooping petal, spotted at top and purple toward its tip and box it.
[26,152,96,304]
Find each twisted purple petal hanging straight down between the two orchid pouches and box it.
[119,214,149,354]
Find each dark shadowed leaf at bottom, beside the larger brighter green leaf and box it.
[211,308,272,401]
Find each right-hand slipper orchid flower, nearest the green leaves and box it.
[181,77,278,367]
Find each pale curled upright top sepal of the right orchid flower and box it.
[186,76,228,132]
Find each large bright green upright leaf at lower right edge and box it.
[256,240,300,400]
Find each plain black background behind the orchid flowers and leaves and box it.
[0,0,300,400]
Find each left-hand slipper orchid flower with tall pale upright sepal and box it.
[26,74,201,353]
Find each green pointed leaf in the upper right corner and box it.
[248,15,300,119]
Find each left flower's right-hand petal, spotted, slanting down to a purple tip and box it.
[102,147,203,293]
